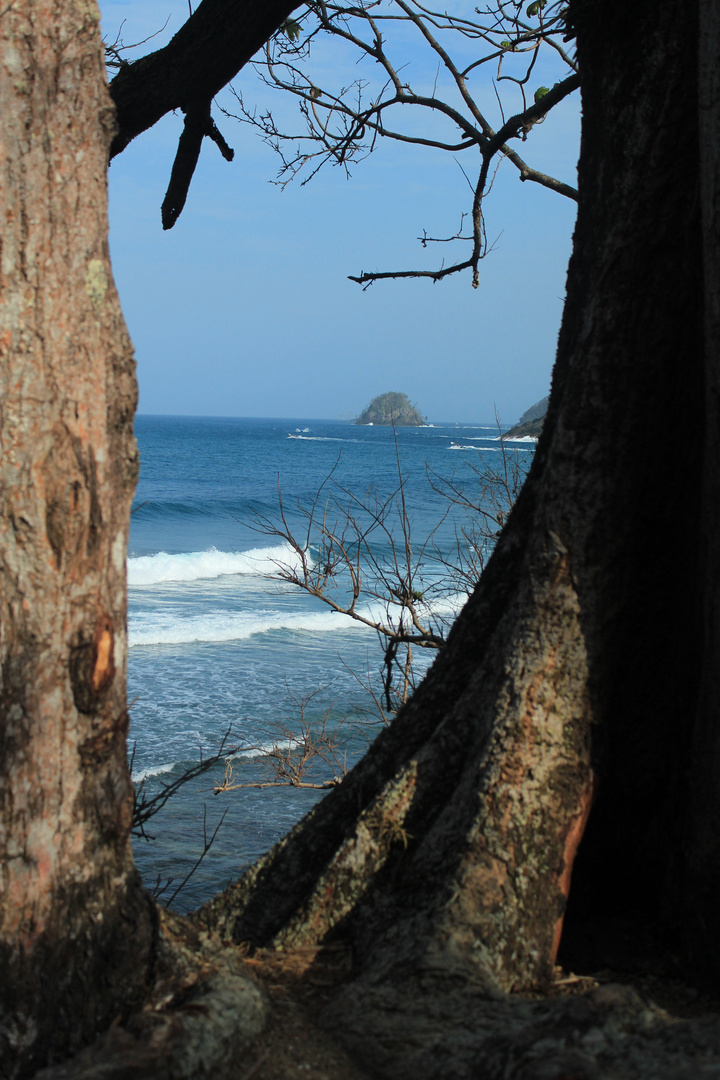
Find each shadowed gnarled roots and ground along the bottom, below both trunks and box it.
[31,924,720,1080]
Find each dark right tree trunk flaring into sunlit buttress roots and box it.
[198,0,708,993]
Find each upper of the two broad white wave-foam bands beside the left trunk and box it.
[127,544,300,585]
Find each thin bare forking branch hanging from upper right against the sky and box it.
[236,0,580,287]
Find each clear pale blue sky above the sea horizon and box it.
[100,0,580,422]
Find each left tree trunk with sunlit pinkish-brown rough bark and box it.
[0,6,153,1076]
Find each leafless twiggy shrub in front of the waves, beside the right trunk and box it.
[241,426,525,713]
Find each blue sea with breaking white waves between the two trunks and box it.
[127,416,533,909]
